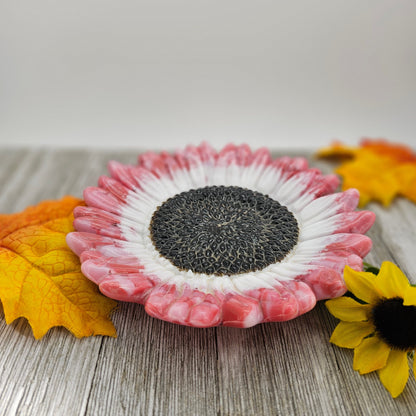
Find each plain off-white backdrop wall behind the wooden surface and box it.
[0,0,416,150]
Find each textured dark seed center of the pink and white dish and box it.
[150,186,299,276]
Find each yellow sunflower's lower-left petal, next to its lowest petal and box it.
[353,336,390,374]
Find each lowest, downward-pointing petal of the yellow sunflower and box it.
[378,350,409,397]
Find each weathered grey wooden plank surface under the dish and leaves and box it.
[0,149,416,416]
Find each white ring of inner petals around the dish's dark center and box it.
[120,164,335,293]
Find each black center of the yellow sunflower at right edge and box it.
[371,298,416,351]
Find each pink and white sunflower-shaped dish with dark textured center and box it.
[67,143,375,328]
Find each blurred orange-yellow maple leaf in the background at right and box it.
[317,139,416,207]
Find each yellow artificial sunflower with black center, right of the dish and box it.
[326,261,416,397]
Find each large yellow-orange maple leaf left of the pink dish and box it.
[0,196,116,339]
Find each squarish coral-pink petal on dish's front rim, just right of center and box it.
[222,293,263,328]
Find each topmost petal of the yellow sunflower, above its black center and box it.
[376,261,410,299]
